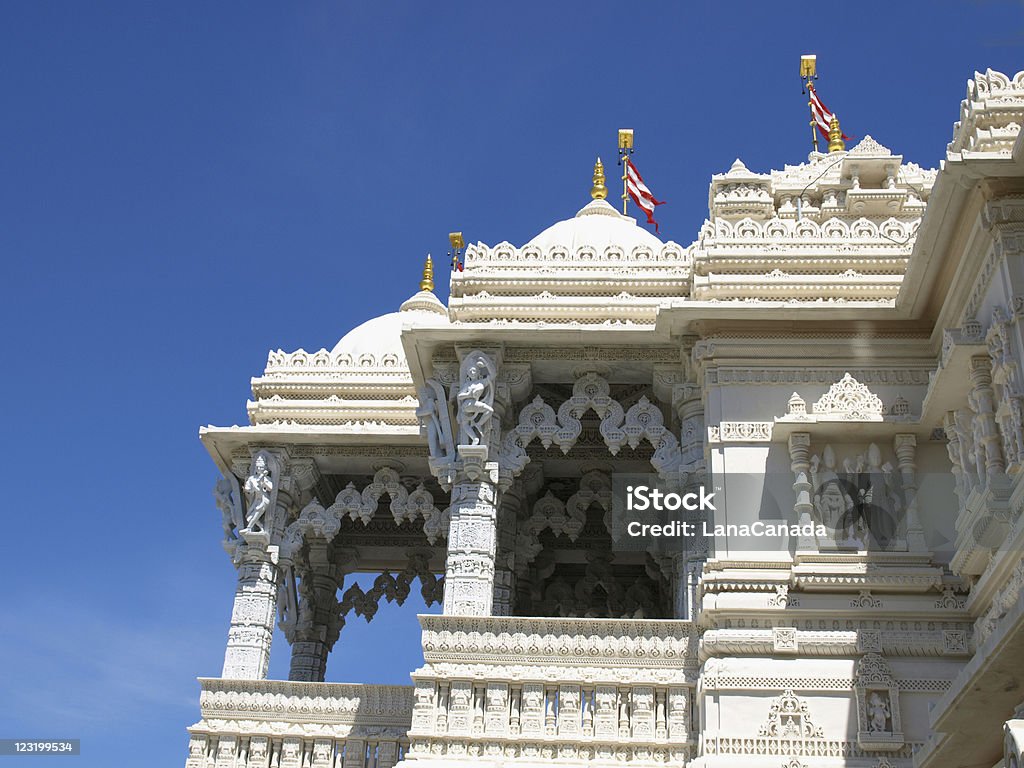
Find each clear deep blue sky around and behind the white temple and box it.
[0,0,1024,768]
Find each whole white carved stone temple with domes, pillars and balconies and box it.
[185,71,1024,768]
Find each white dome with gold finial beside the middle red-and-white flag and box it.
[523,200,665,254]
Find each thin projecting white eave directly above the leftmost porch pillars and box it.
[199,424,426,473]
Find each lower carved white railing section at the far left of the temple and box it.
[185,678,413,768]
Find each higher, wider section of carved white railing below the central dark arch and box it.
[407,615,697,768]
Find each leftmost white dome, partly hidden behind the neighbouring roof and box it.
[331,291,447,367]
